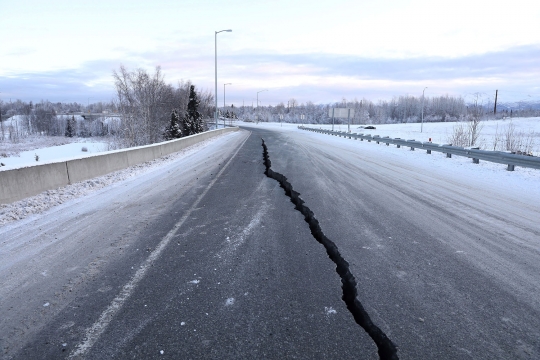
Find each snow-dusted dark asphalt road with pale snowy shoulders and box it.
[0,125,540,359]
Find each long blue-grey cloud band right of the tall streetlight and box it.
[222,46,540,81]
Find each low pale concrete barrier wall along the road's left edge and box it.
[0,127,238,204]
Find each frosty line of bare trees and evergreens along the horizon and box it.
[0,66,540,147]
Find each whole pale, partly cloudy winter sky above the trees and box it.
[0,0,540,106]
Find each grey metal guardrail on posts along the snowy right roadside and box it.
[298,126,540,171]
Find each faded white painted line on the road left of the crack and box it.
[69,132,251,359]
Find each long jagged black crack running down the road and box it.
[262,139,399,360]
